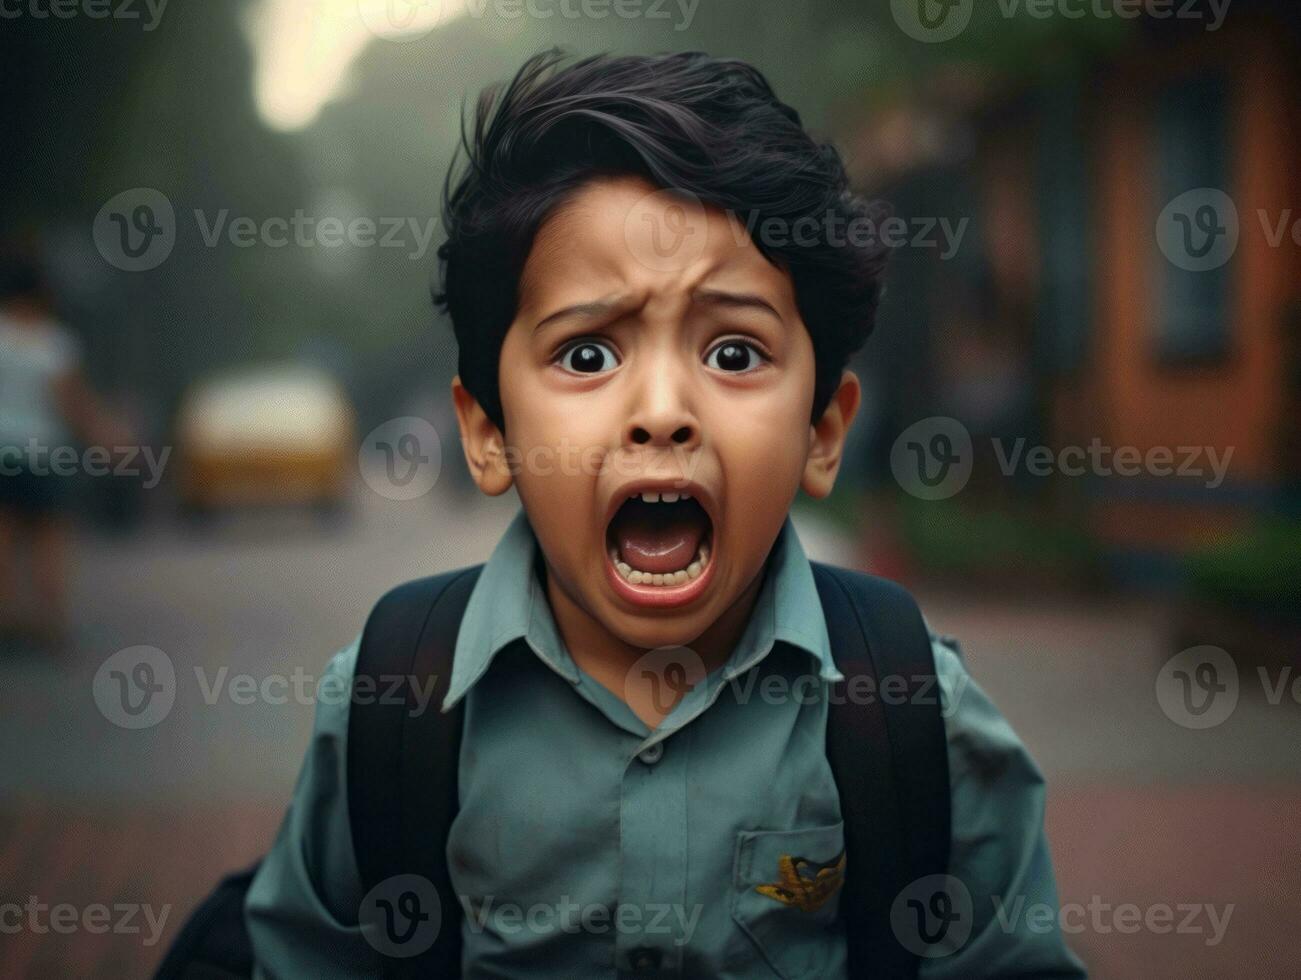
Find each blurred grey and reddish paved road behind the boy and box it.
[0,493,1301,977]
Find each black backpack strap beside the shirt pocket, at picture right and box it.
[813,562,951,980]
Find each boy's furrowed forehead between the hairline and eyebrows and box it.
[520,177,795,315]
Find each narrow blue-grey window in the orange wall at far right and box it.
[1155,75,1232,363]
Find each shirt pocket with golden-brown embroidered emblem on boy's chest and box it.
[732,823,846,980]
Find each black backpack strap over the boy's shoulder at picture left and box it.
[347,565,483,977]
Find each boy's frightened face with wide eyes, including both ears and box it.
[454,177,859,649]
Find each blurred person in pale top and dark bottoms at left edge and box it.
[0,258,131,649]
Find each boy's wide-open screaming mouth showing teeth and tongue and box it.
[605,491,713,605]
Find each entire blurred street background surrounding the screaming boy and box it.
[0,0,1301,977]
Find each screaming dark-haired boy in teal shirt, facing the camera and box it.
[246,53,1082,977]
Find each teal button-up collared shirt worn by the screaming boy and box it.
[246,511,1084,980]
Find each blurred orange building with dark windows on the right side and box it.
[851,0,1301,580]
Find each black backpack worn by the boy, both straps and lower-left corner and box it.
[156,562,951,980]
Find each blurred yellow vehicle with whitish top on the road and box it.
[177,366,356,515]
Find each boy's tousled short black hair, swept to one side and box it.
[435,49,889,429]
